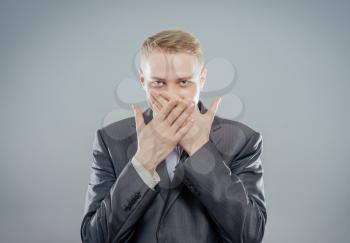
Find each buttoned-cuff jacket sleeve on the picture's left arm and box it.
[80,129,157,243]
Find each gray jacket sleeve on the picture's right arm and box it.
[179,132,267,243]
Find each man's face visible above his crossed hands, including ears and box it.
[139,51,207,115]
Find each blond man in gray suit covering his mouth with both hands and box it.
[81,30,267,243]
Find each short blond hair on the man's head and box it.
[140,29,204,68]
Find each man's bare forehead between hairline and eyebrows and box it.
[144,51,198,78]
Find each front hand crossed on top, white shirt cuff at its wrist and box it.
[133,96,194,175]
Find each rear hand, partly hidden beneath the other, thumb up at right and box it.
[150,90,221,156]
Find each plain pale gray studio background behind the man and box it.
[0,0,350,243]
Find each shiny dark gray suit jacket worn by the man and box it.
[80,101,267,243]
